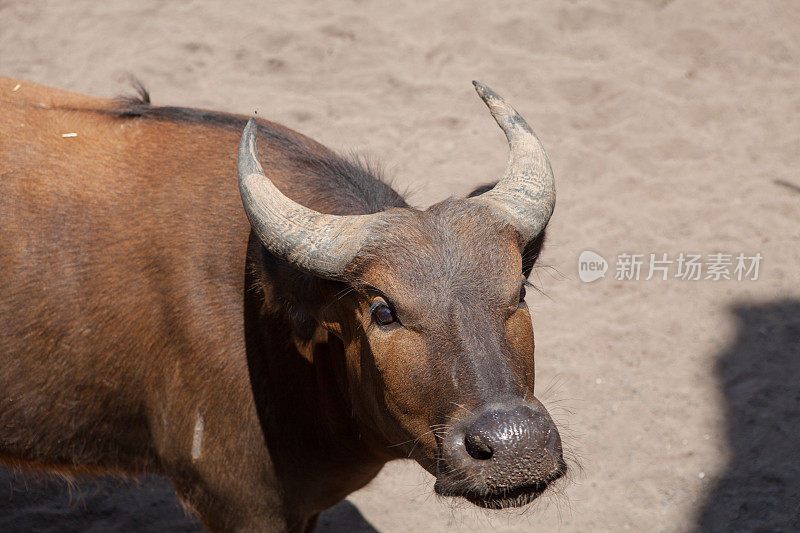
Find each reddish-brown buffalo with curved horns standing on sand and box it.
[0,79,566,531]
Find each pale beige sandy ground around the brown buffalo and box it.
[0,0,800,532]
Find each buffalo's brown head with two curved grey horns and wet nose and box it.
[239,82,566,508]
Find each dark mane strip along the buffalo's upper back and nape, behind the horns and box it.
[109,79,407,214]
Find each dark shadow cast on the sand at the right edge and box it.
[695,300,800,532]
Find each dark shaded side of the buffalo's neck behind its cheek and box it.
[244,235,389,510]
